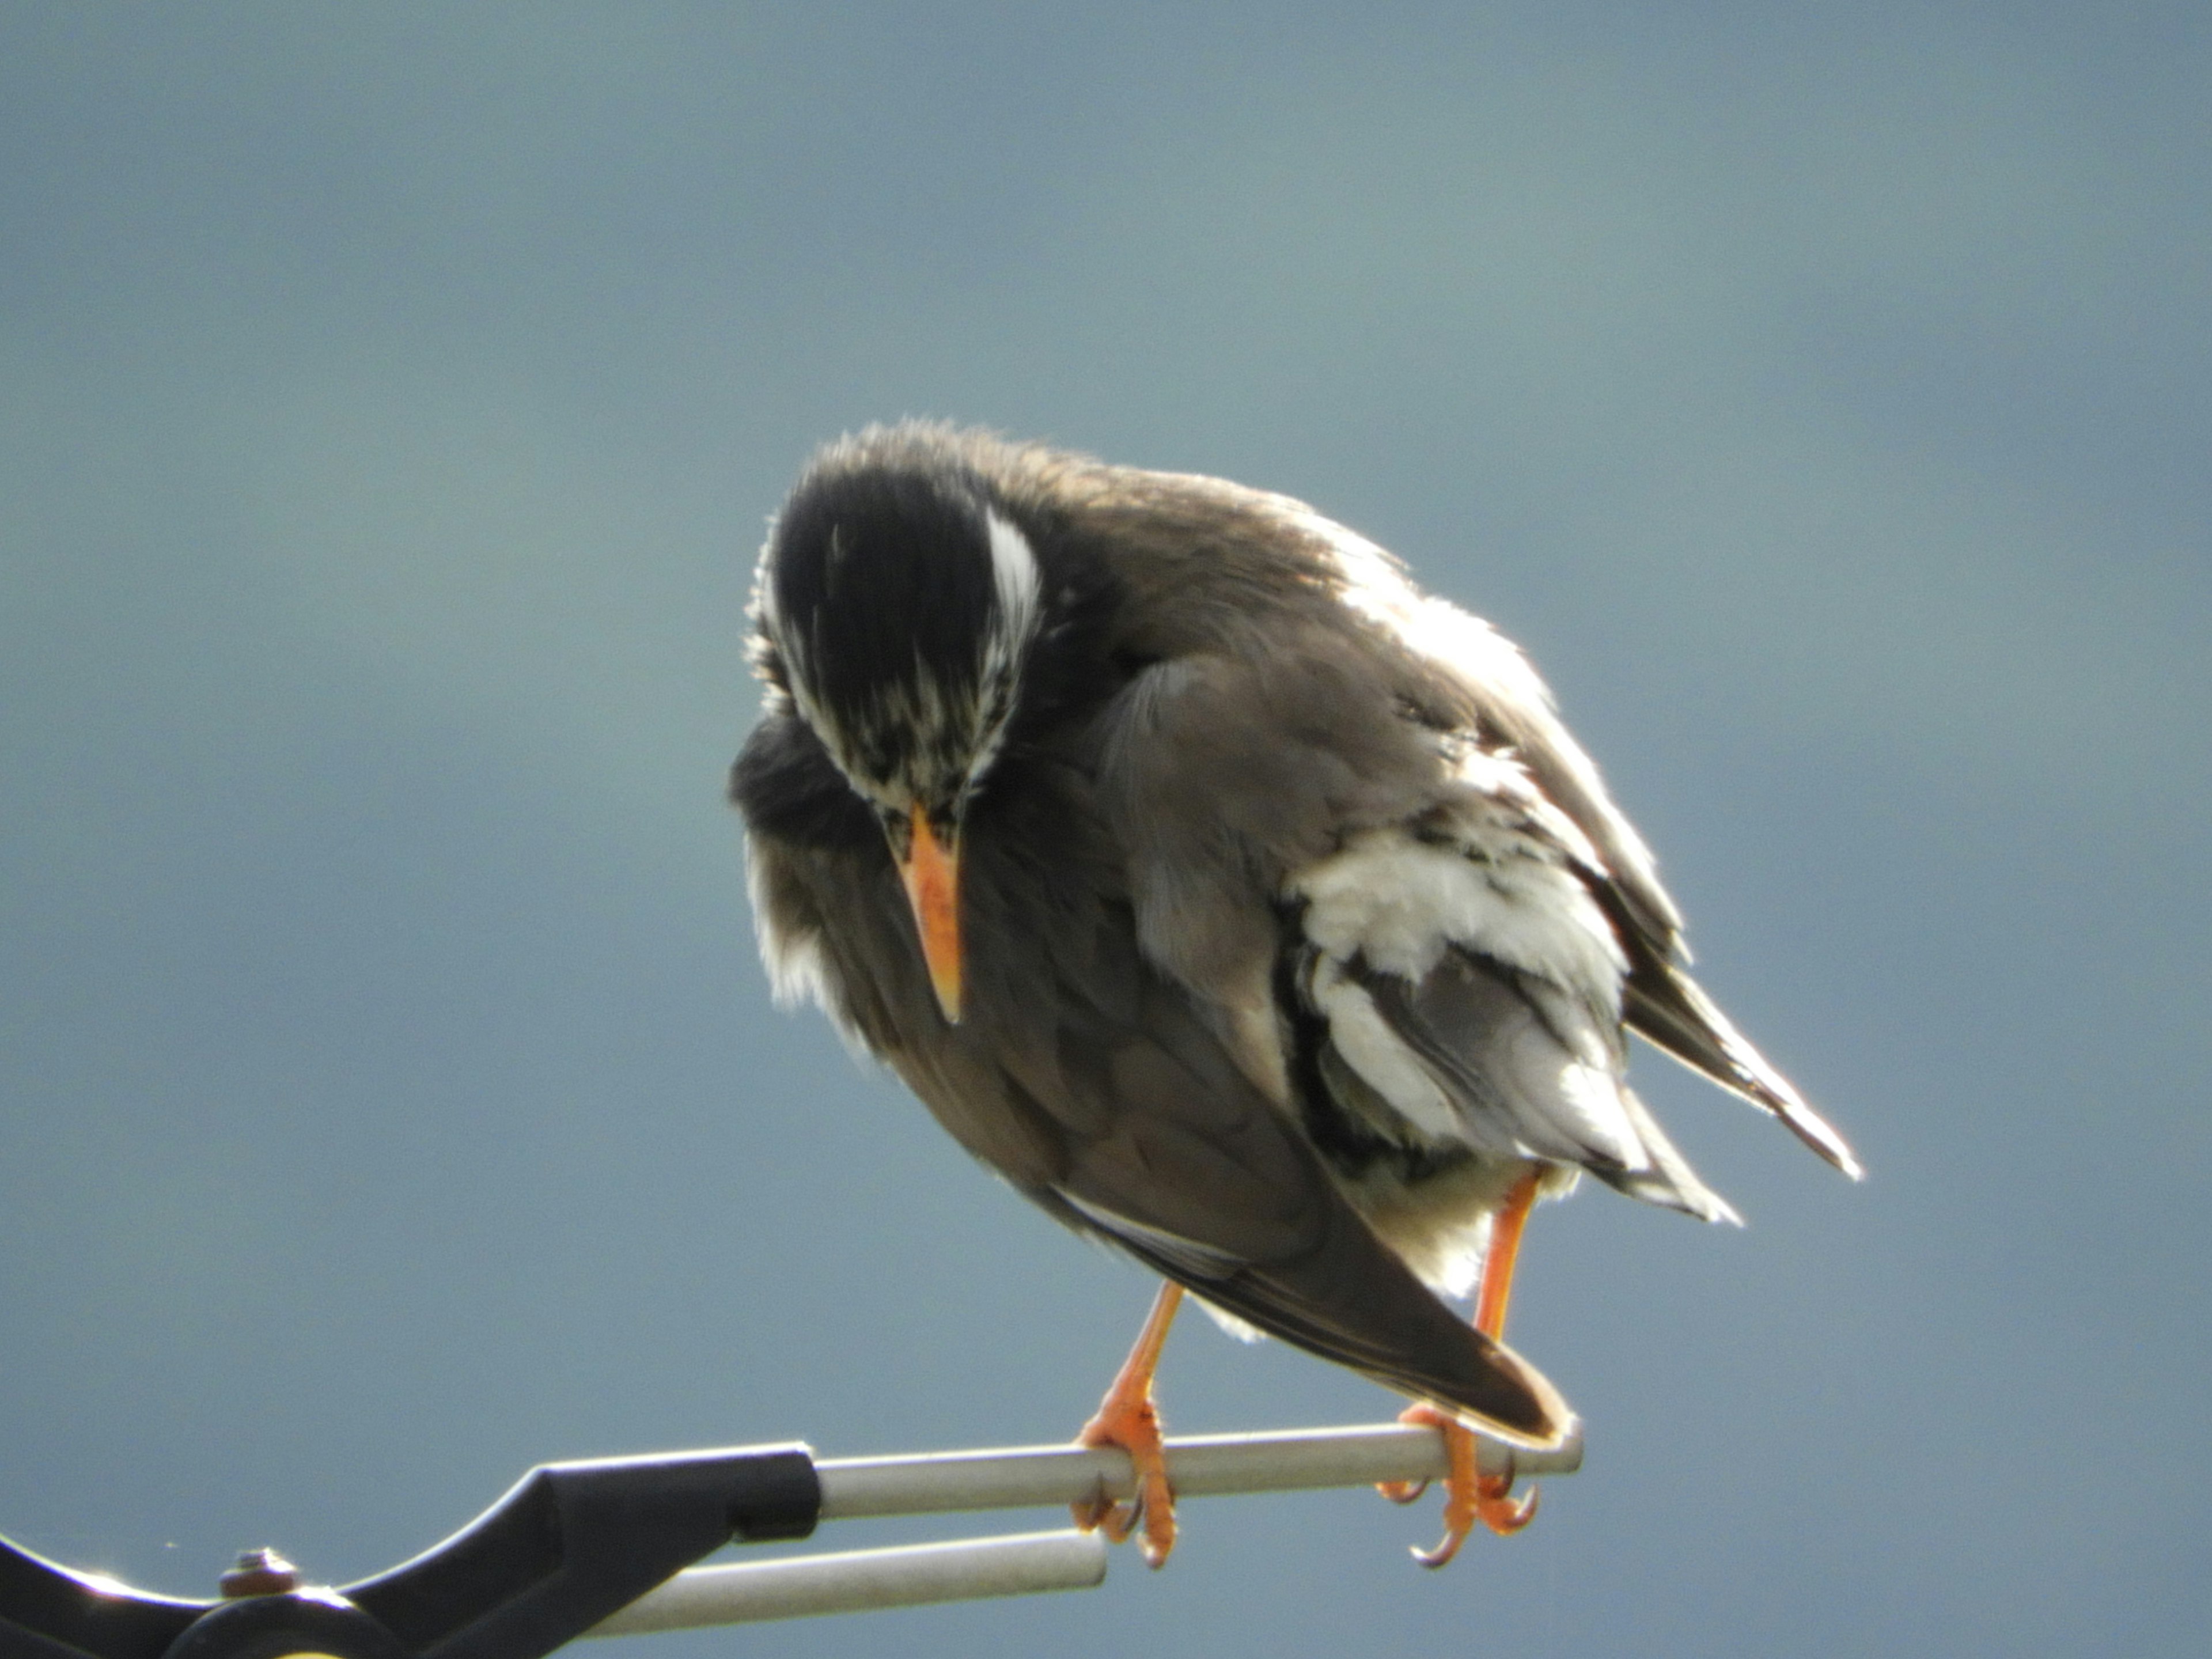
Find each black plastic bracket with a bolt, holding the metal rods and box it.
[0,1446,821,1659]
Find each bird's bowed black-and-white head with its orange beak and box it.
[754,440,1042,1022]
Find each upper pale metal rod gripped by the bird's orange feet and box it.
[814,1422,1582,1520]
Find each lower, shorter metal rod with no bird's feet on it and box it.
[584,1533,1106,1637]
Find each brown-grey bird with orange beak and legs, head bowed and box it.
[730,421,1860,1566]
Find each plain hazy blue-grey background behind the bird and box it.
[0,0,2212,1659]
